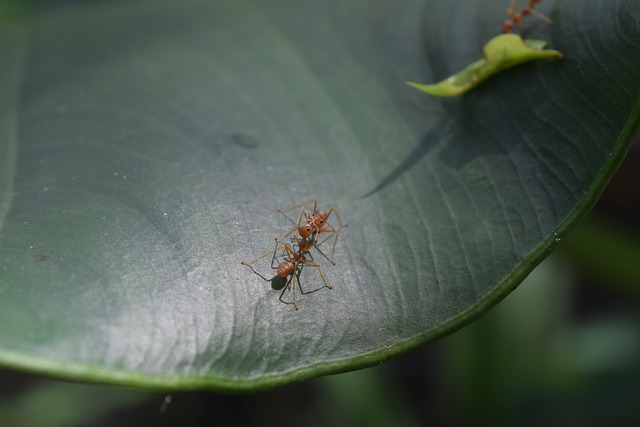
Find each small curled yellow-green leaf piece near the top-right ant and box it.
[407,33,562,97]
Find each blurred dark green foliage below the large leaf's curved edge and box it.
[0,139,640,427]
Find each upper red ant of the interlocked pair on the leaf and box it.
[278,200,348,265]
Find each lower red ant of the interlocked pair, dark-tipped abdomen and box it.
[241,237,331,310]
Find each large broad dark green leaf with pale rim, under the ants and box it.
[0,0,640,390]
